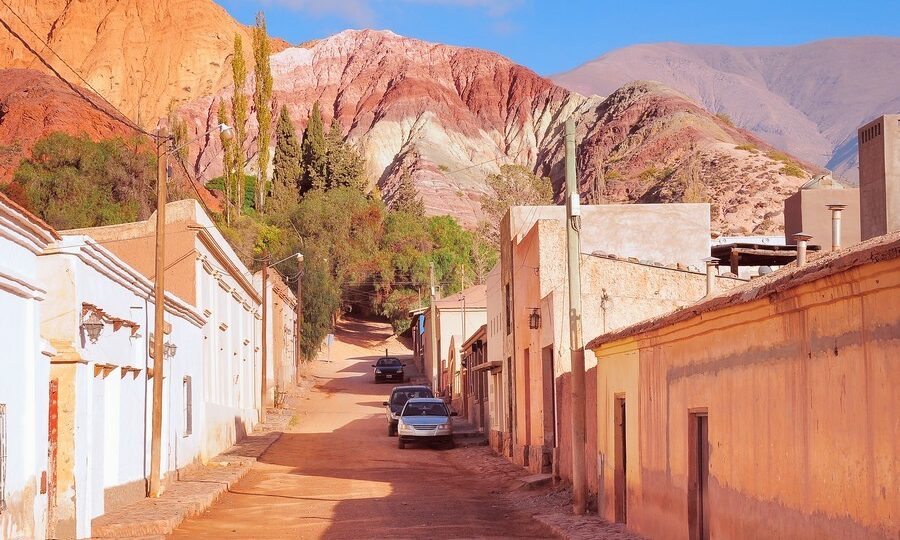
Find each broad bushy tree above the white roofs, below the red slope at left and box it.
[4,133,156,229]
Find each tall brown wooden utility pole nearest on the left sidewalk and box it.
[150,127,169,498]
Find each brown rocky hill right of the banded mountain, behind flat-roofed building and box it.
[578,82,816,234]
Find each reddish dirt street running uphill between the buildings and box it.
[165,322,552,538]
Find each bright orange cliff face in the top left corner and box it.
[0,0,287,127]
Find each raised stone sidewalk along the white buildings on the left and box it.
[91,402,293,540]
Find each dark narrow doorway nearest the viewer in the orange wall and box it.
[688,410,710,540]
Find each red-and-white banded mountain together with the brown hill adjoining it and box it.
[181,31,811,233]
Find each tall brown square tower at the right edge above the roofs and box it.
[857,114,900,240]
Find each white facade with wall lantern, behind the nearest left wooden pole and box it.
[38,236,206,538]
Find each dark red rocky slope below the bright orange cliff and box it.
[0,69,135,182]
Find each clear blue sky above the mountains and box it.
[217,0,900,75]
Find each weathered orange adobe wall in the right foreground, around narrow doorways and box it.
[595,246,900,539]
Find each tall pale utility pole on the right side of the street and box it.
[566,118,587,516]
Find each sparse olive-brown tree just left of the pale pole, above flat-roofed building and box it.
[479,161,553,246]
